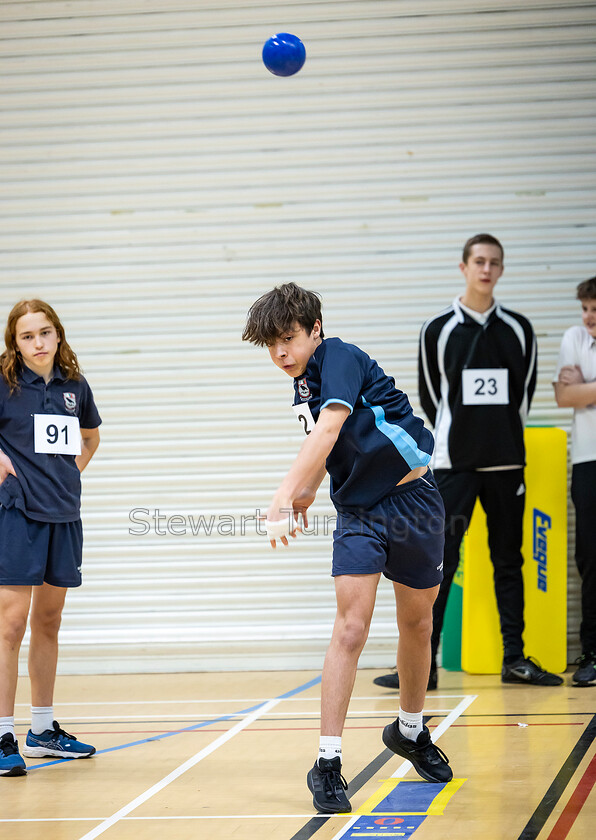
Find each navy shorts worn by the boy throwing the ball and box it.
[332,470,445,589]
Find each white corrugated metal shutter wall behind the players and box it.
[0,0,596,671]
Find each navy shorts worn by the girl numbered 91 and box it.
[0,505,83,586]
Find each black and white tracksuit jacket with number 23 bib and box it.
[418,299,536,470]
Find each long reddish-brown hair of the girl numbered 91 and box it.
[0,298,81,394]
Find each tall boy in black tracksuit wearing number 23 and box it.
[378,234,563,688]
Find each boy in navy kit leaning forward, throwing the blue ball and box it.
[242,283,453,813]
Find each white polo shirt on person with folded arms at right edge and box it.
[553,326,596,464]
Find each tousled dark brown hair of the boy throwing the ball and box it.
[242,283,325,347]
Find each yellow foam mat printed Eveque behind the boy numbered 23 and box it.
[461,428,567,674]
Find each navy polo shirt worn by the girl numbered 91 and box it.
[0,366,101,522]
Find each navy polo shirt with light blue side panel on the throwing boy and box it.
[294,338,434,509]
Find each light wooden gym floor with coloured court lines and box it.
[0,670,596,840]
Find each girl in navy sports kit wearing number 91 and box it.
[0,300,101,776]
